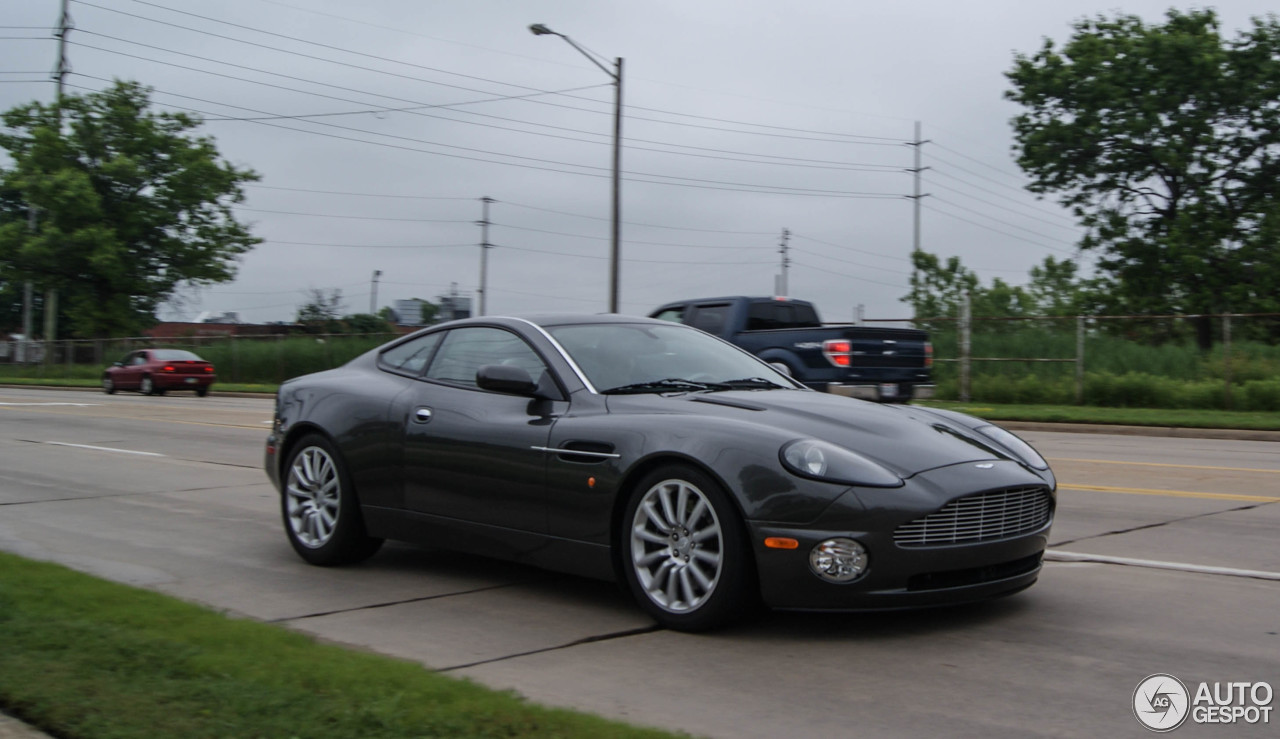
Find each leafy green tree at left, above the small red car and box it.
[0,81,261,337]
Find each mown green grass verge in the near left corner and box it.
[0,553,673,739]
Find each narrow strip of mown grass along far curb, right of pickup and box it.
[919,401,1280,430]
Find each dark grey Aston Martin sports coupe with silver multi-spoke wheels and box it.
[265,315,1056,630]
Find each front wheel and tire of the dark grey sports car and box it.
[620,465,758,631]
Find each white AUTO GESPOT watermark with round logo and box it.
[1133,672,1275,734]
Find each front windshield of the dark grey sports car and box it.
[547,323,796,392]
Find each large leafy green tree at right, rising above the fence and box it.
[1006,10,1280,348]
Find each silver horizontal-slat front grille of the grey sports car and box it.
[893,487,1053,547]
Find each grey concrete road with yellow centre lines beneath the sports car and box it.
[0,388,1280,738]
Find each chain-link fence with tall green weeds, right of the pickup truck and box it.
[865,304,1280,411]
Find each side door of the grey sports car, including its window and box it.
[397,327,567,533]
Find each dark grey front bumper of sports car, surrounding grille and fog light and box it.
[748,462,1053,611]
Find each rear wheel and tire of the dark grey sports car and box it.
[280,434,383,566]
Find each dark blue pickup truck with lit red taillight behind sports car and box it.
[649,296,933,402]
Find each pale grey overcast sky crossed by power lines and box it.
[0,0,1275,321]
